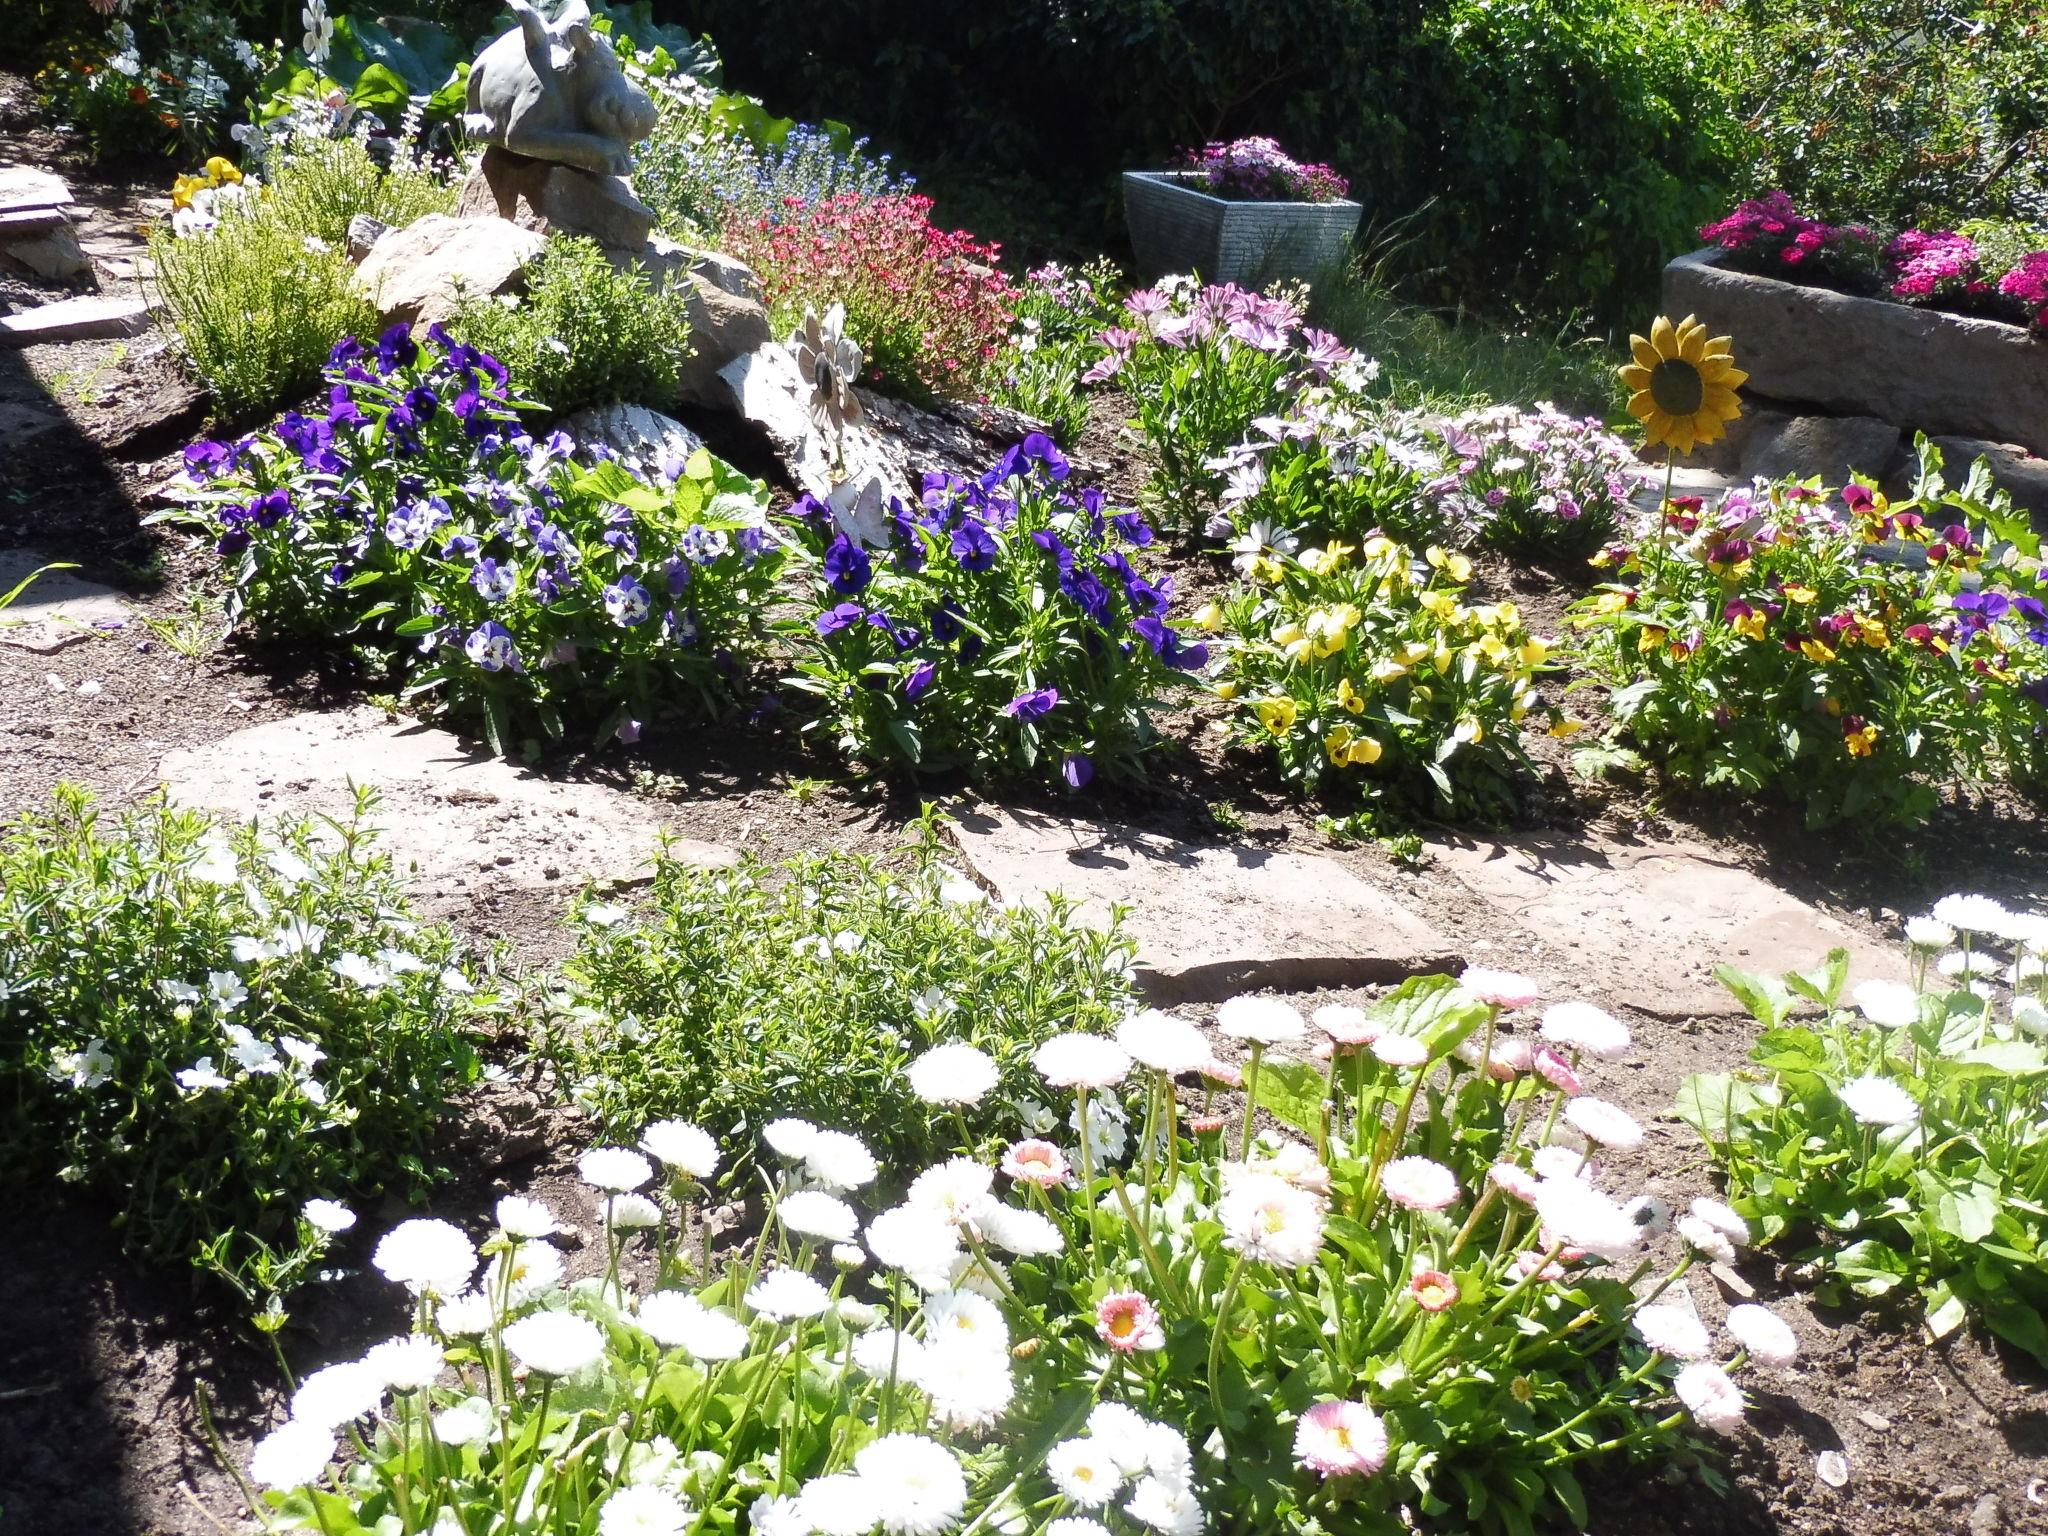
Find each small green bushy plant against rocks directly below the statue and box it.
[451,236,690,414]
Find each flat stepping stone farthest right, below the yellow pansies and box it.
[1430,834,1907,1020]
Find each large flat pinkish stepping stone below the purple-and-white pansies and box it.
[156,707,739,915]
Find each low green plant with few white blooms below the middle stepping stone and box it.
[545,819,1133,1157]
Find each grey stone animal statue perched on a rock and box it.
[465,0,655,176]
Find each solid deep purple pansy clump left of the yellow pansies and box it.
[791,434,1208,788]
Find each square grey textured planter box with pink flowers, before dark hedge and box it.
[1124,170,1362,289]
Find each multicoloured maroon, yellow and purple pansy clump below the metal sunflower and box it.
[1571,442,2048,821]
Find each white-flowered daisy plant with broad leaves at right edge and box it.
[1679,895,2048,1364]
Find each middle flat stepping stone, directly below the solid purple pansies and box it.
[952,805,1458,1004]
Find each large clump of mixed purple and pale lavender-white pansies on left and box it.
[167,326,780,750]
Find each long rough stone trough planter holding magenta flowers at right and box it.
[1663,248,2048,457]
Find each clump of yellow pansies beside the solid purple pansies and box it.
[1202,537,1569,815]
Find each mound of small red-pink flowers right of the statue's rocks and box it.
[725,193,1018,399]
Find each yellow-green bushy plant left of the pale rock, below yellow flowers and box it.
[150,128,455,418]
